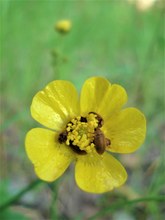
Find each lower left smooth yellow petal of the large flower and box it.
[25,128,74,181]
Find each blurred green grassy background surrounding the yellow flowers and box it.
[0,0,165,220]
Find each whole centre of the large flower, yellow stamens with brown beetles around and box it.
[58,112,110,154]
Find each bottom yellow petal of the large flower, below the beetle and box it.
[75,153,127,193]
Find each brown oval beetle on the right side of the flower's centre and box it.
[93,127,111,154]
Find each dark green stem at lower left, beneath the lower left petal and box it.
[0,179,43,211]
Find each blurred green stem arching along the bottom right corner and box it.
[89,196,165,220]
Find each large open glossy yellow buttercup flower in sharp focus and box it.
[25,77,146,193]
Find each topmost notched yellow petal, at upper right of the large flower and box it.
[80,77,127,120]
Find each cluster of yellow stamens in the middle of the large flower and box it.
[65,113,99,154]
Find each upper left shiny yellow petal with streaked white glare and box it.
[31,80,79,130]
